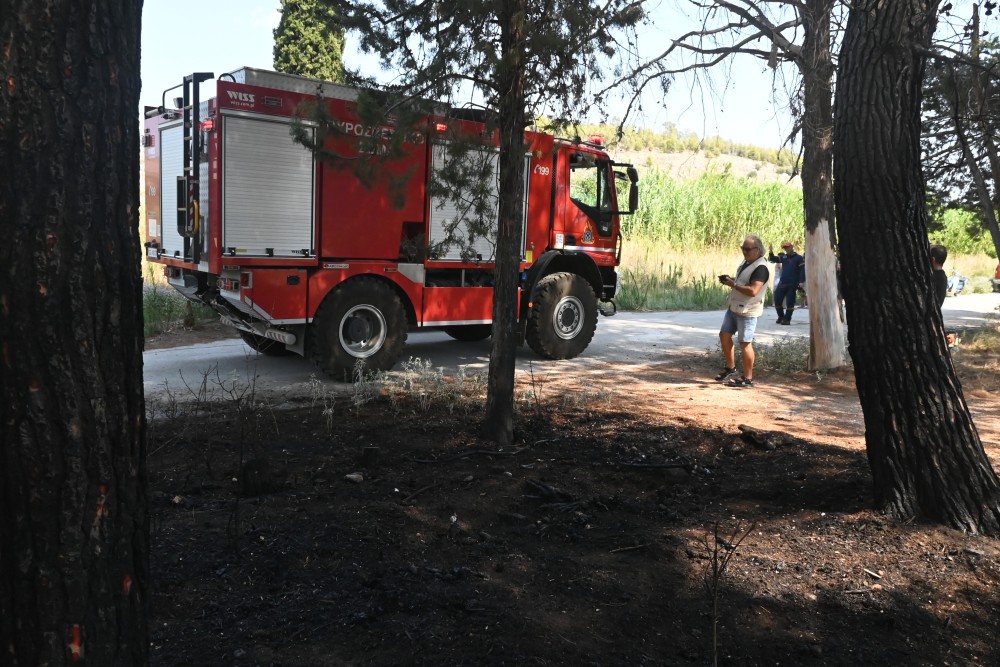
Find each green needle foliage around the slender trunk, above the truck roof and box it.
[319,0,646,127]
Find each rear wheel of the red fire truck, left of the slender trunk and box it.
[306,277,407,381]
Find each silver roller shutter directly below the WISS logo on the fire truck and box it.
[222,115,316,258]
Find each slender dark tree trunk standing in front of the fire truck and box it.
[483,0,527,445]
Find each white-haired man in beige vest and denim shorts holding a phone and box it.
[715,234,770,388]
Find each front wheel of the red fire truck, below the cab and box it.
[527,273,597,359]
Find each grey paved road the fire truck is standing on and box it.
[143,294,1000,396]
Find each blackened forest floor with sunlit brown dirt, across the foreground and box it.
[148,320,1000,667]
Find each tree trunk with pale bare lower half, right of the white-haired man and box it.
[798,0,844,369]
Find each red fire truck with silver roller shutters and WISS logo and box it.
[143,68,638,378]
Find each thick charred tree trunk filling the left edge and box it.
[0,0,149,666]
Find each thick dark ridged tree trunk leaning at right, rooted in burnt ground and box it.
[834,0,1000,535]
